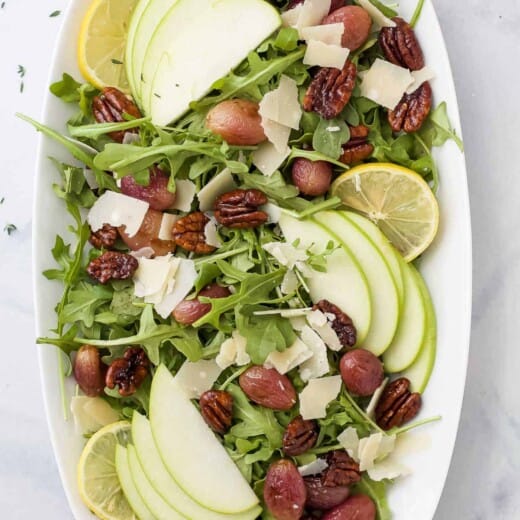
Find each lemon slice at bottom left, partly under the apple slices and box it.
[78,421,137,520]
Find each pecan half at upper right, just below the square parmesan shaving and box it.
[388,81,433,133]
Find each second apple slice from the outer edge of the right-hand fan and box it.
[383,260,427,373]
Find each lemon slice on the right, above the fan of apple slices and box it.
[331,163,439,262]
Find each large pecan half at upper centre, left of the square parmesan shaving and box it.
[303,60,357,119]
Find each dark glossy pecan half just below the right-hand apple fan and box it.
[376,377,422,430]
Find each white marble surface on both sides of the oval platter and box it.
[0,0,520,520]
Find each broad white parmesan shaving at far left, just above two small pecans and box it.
[87,191,150,237]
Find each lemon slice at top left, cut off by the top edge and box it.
[78,0,137,93]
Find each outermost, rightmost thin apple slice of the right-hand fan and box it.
[402,264,437,393]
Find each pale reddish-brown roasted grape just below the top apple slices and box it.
[206,99,266,146]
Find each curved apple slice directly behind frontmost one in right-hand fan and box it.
[313,211,400,356]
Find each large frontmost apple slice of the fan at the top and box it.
[141,0,281,126]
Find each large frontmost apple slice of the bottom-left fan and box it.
[150,365,259,514]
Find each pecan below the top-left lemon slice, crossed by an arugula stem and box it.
[92,87,141,143]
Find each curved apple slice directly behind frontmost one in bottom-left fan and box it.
[132,412,262,520]
